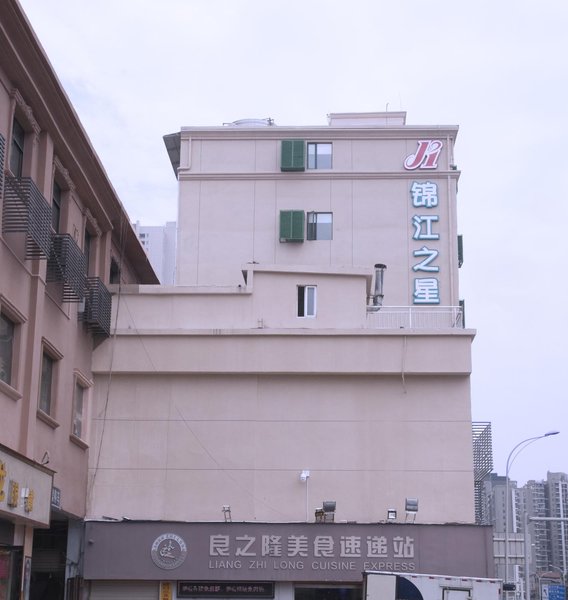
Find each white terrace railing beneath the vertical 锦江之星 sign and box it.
[367,306,464,329]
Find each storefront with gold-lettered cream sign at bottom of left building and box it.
[0,446,53,600]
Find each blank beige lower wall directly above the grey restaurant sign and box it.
[88,270,474,522]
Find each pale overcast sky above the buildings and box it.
[20,0,568,484]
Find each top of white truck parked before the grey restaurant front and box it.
[363,571,503,600]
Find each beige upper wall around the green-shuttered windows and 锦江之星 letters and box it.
[176,119,459,306]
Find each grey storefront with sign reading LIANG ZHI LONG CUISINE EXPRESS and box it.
[84,521,494,600]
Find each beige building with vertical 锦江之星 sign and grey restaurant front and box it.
[83,113,493,600]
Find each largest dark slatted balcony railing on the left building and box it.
[2,176,51,258]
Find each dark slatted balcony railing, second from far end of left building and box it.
[46,233,87,302]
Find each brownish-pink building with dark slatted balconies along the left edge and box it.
[0,0,157,600]
